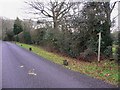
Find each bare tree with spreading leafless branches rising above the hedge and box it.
[26,0,73,31]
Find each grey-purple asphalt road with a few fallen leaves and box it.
[2,42,114,88]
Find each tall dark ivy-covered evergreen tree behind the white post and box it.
[80,2,112,52]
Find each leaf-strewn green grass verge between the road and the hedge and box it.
[17,43,120,85]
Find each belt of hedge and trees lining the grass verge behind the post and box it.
[12,0,116,62]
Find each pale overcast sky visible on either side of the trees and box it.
[0,0,118,19]
